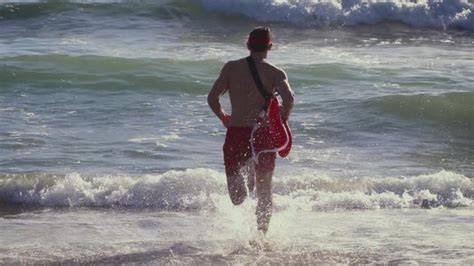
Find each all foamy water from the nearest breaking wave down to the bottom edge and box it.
[0,168,474,264]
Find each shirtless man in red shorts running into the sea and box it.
[207,27,294,234]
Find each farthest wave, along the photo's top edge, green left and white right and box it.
[0,0,474,31]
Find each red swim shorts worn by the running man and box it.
[224,127,276,176]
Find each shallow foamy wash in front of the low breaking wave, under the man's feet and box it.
[0,198,474,264]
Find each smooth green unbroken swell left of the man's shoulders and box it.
[0,55,221,93]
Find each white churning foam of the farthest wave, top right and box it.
[201,0,474,30]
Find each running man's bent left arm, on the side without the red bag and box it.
[207,63,230,128]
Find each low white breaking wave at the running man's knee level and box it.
[0,169,474,211]
